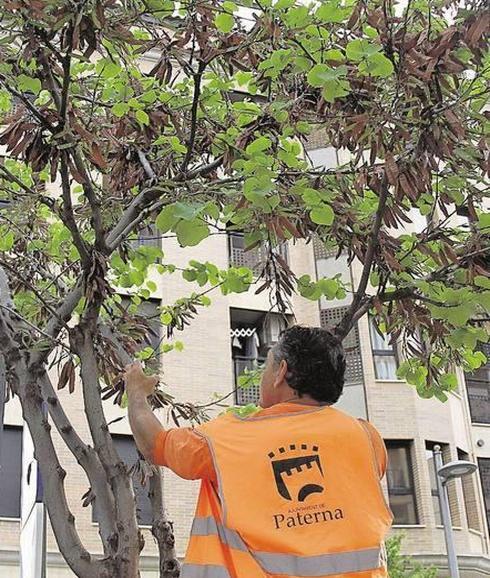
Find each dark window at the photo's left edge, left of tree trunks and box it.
[0,426,22,518]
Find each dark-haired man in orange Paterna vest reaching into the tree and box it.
[126,326,393,578]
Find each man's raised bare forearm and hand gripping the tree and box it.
[124,363,164,461]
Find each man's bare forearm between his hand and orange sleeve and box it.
[128,392,163,461]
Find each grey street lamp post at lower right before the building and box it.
[433,446,478,578]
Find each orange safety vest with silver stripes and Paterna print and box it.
[181,406,393,578]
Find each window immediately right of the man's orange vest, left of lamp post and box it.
[386,441,418,525]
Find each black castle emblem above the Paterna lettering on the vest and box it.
[268,444,324,502]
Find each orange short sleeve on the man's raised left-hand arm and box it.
[153,427,216,481]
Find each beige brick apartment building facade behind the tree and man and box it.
[0,142,490,578]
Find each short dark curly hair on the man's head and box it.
[272,325,345,404]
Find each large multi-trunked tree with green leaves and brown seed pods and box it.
[0,0,490,578]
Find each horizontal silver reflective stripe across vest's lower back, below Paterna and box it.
[252,548,381,576]
